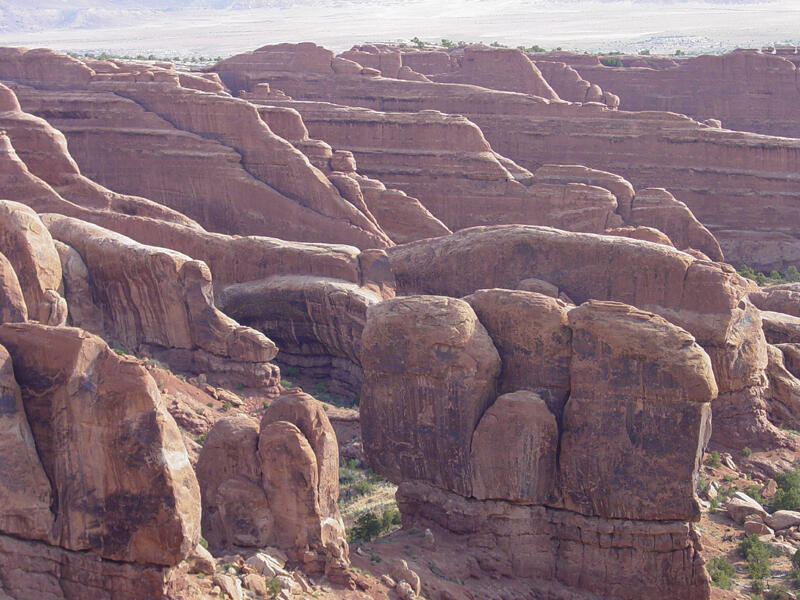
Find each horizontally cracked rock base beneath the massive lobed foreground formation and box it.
[397,481,710,600]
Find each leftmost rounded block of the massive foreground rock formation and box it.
[361,296,500,495]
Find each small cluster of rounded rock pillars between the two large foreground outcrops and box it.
[197,389,348,574]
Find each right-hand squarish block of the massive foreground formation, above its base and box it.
[559,301,717,521]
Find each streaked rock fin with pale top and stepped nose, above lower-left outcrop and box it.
[46,215,278,392]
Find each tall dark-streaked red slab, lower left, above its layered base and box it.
[0,323,200,566]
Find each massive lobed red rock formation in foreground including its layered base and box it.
[361,289,717,599]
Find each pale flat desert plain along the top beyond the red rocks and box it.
[0,0,800,56]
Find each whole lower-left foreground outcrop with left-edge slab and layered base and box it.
[0,323,200,600]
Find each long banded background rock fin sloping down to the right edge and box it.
[214,46,800,269]
